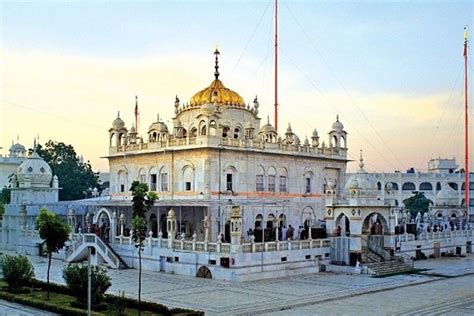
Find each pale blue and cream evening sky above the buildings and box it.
[0,0,474,172]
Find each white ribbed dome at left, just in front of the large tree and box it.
[16,151,53,188]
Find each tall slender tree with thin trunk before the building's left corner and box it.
[130,181,158,315]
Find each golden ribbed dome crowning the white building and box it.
[190,79,245,107]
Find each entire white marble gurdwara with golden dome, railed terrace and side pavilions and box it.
[1,50,473,281]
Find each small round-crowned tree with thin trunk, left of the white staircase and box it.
[36,208,71,300]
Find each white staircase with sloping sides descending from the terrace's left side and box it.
[65,234,128,269]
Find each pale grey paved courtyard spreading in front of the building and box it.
[1,255,474,315]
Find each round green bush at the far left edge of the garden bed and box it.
[2,255,35,290]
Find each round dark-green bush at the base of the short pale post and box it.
[63,263,112,304]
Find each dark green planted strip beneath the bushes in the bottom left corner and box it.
[0,280,204,316]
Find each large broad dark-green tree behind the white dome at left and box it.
[30,140,99,201]
